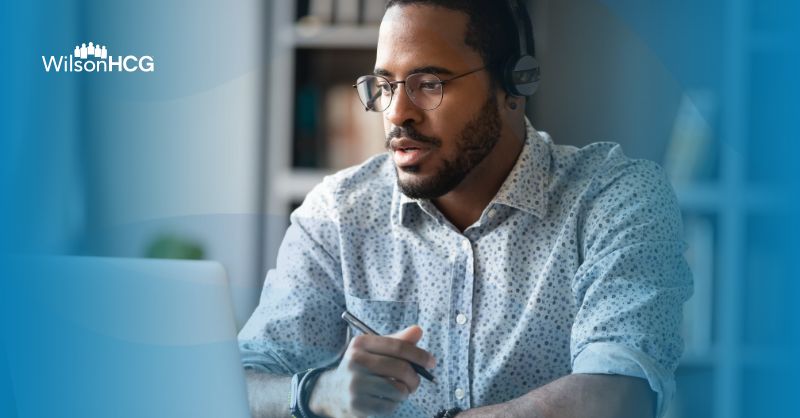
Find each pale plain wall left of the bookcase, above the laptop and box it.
[83,0,265,326]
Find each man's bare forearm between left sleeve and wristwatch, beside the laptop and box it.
[245,369,292,418]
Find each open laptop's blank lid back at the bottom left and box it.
[0,256,250,417]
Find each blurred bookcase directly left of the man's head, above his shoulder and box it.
[261,0,383,274]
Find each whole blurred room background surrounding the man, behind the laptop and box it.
[0,0,800,417]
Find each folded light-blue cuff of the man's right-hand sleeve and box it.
[572,343,675,418]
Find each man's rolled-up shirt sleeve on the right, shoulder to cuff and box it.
[571,162,692,417]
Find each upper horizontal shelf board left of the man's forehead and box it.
[281,24,380,49]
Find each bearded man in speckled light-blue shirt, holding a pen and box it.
[239,0,691,418]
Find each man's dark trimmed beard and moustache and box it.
[385,99,503,200]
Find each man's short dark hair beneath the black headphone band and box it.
[386,0,535,93]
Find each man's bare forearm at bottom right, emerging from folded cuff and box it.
[458,374,655,418]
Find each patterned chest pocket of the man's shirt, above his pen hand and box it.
[344,294,418,335]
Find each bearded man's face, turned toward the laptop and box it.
[375,5,503,199]
